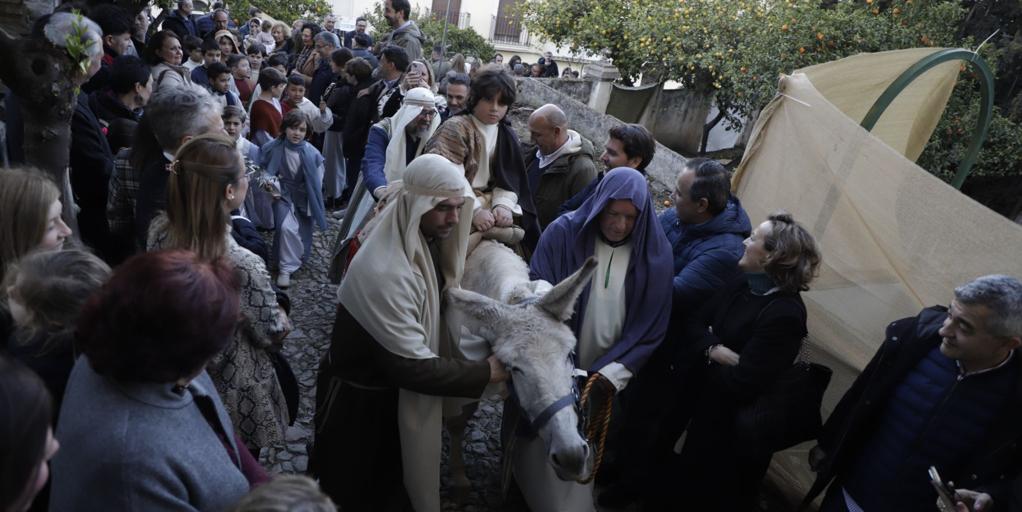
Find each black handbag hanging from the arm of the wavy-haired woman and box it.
[735,355,833,453]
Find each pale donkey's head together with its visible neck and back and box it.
[447,241,596,480]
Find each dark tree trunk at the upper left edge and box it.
[0,22,80,233]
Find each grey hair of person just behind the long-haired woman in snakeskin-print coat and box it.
[145,85,223,151]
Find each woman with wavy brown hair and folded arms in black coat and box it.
[646,213,820,511]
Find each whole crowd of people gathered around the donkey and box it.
[0,0,1022,512]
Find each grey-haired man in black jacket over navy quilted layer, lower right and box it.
[806,276,1022,512]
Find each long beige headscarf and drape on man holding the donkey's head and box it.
[337,154,474,512]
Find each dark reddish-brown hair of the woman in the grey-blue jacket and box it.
[76,250,240,382]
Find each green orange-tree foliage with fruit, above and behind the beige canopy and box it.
[522,0,1022,179]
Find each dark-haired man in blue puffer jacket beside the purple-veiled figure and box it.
[599,158,752,508]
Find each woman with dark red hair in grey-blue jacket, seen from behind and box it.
[50,250,267,510]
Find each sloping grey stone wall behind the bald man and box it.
[514,79,687,194]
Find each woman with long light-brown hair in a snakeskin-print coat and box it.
[149,134,291,456]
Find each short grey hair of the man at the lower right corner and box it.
[955,274,1022,336]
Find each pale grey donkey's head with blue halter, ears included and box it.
[448,258,596,480]
